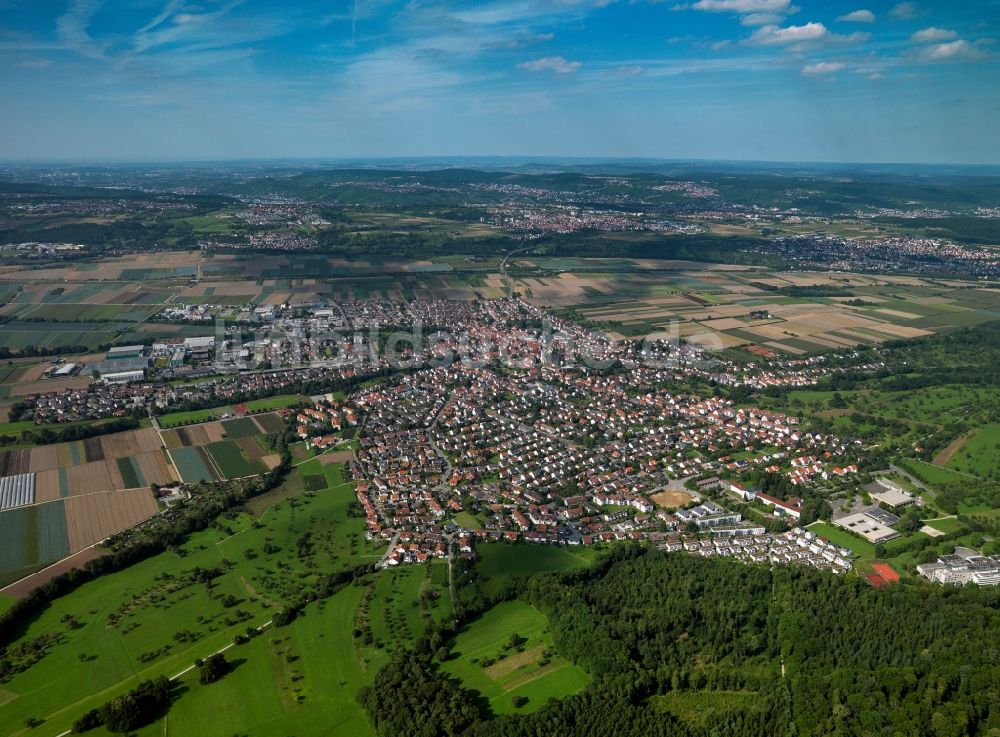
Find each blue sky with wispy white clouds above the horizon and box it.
[0,0,1000,164]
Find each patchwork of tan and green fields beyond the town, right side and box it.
[540,269,1000,356]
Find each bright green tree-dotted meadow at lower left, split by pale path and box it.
[0,462,392,737]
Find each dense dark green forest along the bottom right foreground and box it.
[359,547,1000,737]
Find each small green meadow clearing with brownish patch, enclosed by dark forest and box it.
[441,601,590,714]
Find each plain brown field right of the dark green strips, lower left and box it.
[66,489,158,552]
